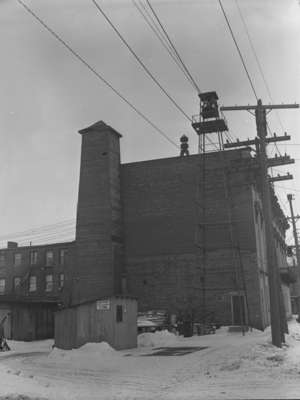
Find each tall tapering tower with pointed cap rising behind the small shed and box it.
[72,121,123,304]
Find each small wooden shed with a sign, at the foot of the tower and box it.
[54,296,137,350]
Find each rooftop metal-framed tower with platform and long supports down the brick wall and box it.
[192,91,249,334]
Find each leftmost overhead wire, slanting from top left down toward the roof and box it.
[16,0,179,148]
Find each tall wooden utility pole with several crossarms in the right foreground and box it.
[220,99,299,347]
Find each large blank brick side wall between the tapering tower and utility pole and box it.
[121,151,263,328]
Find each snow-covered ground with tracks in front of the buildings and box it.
[0,320,300,400]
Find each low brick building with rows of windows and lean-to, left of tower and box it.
[0,242,74,340]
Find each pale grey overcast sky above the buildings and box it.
[0,0,300,244]
